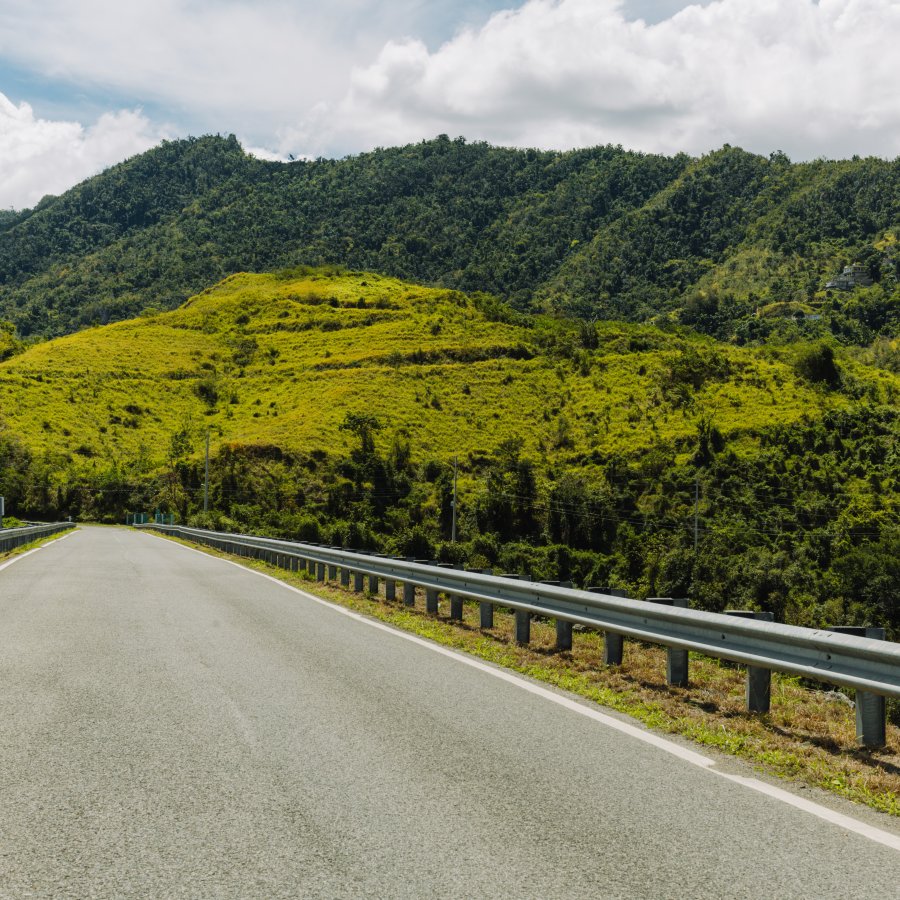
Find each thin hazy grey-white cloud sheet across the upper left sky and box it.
[0,0,512,143]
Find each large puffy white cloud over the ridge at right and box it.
[318,0,900,158]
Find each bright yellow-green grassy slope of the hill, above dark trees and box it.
[0,273,888,471]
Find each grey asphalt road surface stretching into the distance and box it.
[0,528,900,900]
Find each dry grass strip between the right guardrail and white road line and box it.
[158,537,900,816]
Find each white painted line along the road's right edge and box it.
[139,532,900,851]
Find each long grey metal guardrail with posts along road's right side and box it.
[137,524,900,747]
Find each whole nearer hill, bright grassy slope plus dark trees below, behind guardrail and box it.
[0,270,900,635]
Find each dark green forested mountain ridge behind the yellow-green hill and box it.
[0,136,900,344]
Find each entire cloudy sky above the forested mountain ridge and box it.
[0,0,900,208]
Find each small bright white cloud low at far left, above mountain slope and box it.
[0,94,164,209]
